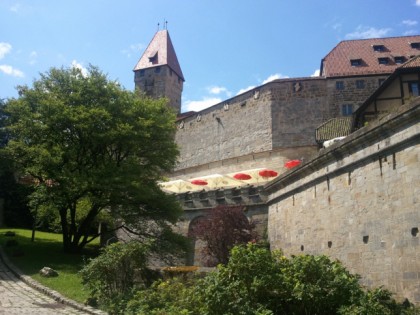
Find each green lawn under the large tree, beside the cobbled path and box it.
[0,228,98,303]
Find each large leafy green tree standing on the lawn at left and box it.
[3,66,181,252]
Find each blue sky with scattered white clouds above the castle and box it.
[0,0,420,111]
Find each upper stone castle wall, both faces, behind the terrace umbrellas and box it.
[171,76,388,179]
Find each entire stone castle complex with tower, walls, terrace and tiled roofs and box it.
[135,31,420,304]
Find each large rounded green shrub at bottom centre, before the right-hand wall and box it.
[195,244,361,315]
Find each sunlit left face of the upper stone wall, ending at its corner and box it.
[175,86,272,171]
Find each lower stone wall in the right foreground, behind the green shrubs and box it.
[266,101,420,304]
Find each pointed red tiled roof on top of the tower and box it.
[134,30,185,81]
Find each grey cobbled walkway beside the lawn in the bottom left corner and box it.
[0,249,104,315]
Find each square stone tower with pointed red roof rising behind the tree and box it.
[133,29,185,113]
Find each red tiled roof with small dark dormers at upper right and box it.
[320,35,420,77]
